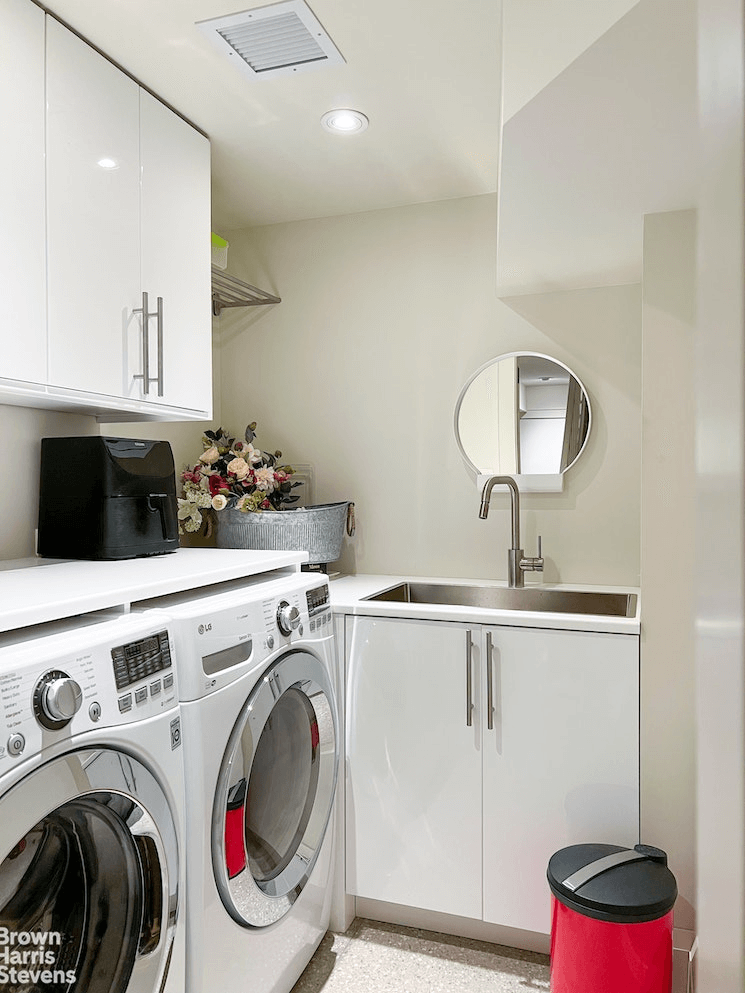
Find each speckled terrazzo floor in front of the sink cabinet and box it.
[292,918,549,993]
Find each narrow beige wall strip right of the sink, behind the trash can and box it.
[641,210,696,930]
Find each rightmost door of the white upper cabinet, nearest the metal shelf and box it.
[140,90,212,418]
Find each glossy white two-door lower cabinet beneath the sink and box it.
[346,617,639,933]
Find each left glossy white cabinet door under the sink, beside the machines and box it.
[346,617,481,918]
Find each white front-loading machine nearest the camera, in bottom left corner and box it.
[0,613,185,993]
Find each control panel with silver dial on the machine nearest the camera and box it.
[0,614,178,774]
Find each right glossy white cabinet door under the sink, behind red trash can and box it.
[484,628,639,932]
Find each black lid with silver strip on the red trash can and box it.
[546,845,678,924]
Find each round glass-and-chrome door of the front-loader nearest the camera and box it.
[0,748,179,993]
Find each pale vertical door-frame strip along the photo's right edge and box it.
[695,0,745,993]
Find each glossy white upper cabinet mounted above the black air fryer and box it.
[0,0,212,420]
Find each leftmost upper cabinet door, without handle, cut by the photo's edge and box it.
[0,0,47,383]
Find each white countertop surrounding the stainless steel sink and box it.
[330,575,641,635]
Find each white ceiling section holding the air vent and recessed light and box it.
[44,0,500,231]
